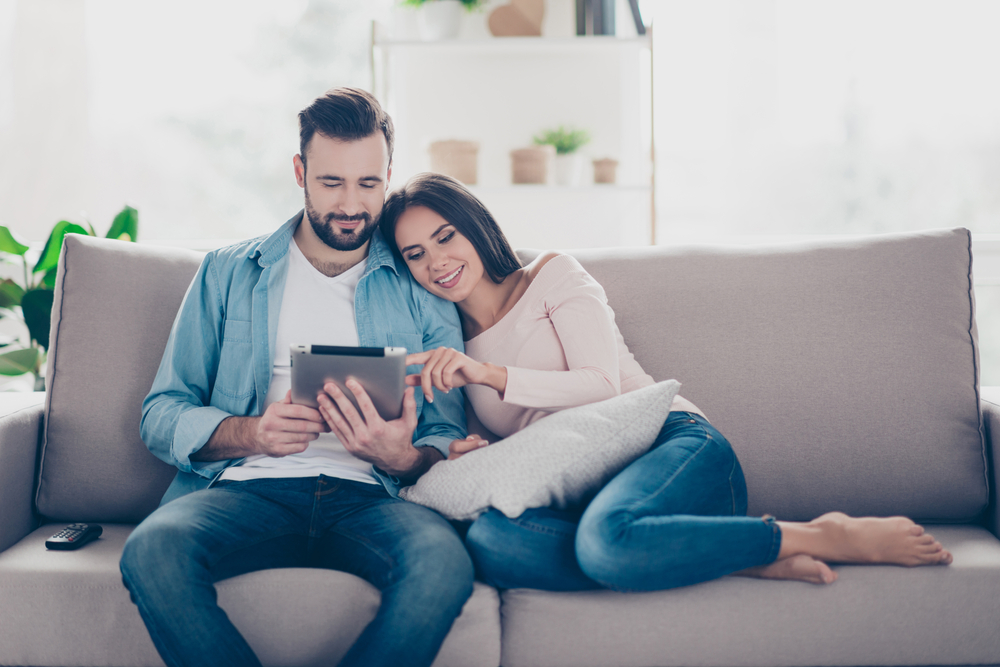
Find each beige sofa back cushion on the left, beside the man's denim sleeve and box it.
[36,234,202,522]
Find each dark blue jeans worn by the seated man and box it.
[121,475,474,667]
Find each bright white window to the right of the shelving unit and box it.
[643,0,1000,385]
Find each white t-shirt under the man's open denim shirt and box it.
[220,238,379,484]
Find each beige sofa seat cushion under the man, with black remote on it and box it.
[0,524,500,667]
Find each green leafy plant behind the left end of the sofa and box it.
[0,206,139,391]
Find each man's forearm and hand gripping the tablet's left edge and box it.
[191,391,330,461]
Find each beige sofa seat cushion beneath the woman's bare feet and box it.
[501,526,1000,667]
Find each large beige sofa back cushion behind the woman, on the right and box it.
[523,229,988,521]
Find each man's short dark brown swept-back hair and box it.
[299,88,393,164]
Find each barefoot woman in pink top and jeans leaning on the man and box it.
[366,174,951,590]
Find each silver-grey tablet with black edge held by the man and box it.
[291,345,406,421]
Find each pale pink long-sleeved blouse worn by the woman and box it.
[465,255,654,437]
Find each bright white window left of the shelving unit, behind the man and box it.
[0,0,392,241]
